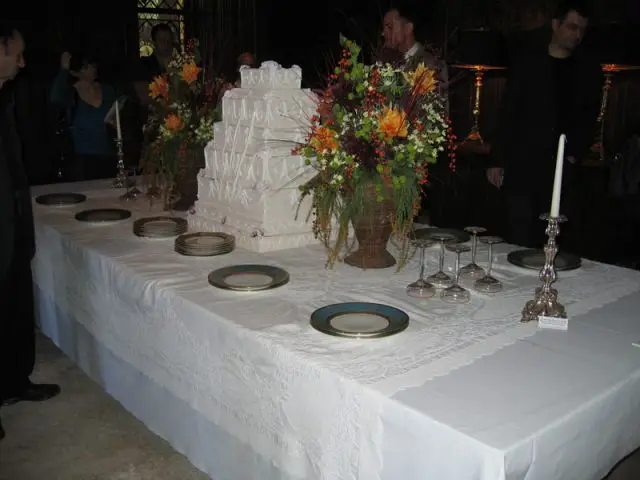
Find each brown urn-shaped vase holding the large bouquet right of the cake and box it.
[344,185,396,270]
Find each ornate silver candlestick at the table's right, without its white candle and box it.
[521,213,567,322]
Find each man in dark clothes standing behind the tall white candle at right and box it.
[487,3,603,250]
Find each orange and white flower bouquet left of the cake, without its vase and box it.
[144,40,224,180]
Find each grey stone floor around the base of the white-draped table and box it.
[0,336,640,480]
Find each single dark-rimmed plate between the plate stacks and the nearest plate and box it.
[209,265,289,292]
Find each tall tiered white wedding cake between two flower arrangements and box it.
[189,62,316,252]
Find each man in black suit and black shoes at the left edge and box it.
[0,23,60,437]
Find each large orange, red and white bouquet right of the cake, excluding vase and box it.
[294,37,451,268]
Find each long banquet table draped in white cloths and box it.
[33,182,640,480]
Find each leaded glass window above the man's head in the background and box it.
[138,0,184,57]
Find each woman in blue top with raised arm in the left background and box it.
[51,52,117,181]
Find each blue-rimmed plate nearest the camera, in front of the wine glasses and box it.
[311,302,409,338]
